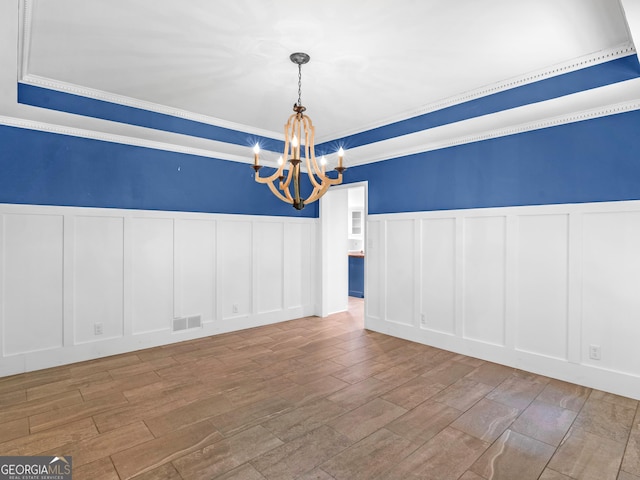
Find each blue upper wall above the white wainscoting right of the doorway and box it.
[345,111,640,214]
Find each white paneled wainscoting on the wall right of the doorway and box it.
[365,201,640,399]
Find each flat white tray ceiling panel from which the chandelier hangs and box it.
[17,0,632,161]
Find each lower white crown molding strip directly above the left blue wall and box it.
[0,115,253,163]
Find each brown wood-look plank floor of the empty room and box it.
[0,299,640,480]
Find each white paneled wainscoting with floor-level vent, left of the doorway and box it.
[0,204,319,376]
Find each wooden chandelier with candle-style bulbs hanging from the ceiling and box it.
[253,53,346,210]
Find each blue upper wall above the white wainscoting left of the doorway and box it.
[0,126,318,217]
